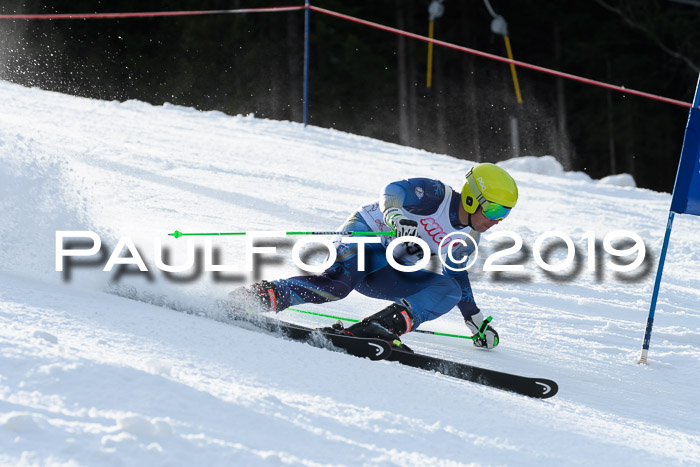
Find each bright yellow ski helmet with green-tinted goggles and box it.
[462,163,518,220]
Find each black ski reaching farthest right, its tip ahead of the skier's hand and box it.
[386,348,559,399]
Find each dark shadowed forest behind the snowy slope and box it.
[0,0,700,191]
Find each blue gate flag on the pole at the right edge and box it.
[671,92,700,216]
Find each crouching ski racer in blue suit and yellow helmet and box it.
[231,164,518,349]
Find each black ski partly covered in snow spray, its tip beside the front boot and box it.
[231,313,393,360]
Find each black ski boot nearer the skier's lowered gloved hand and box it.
[345,300,413,352]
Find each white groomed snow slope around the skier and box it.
[0,82,700,466]
